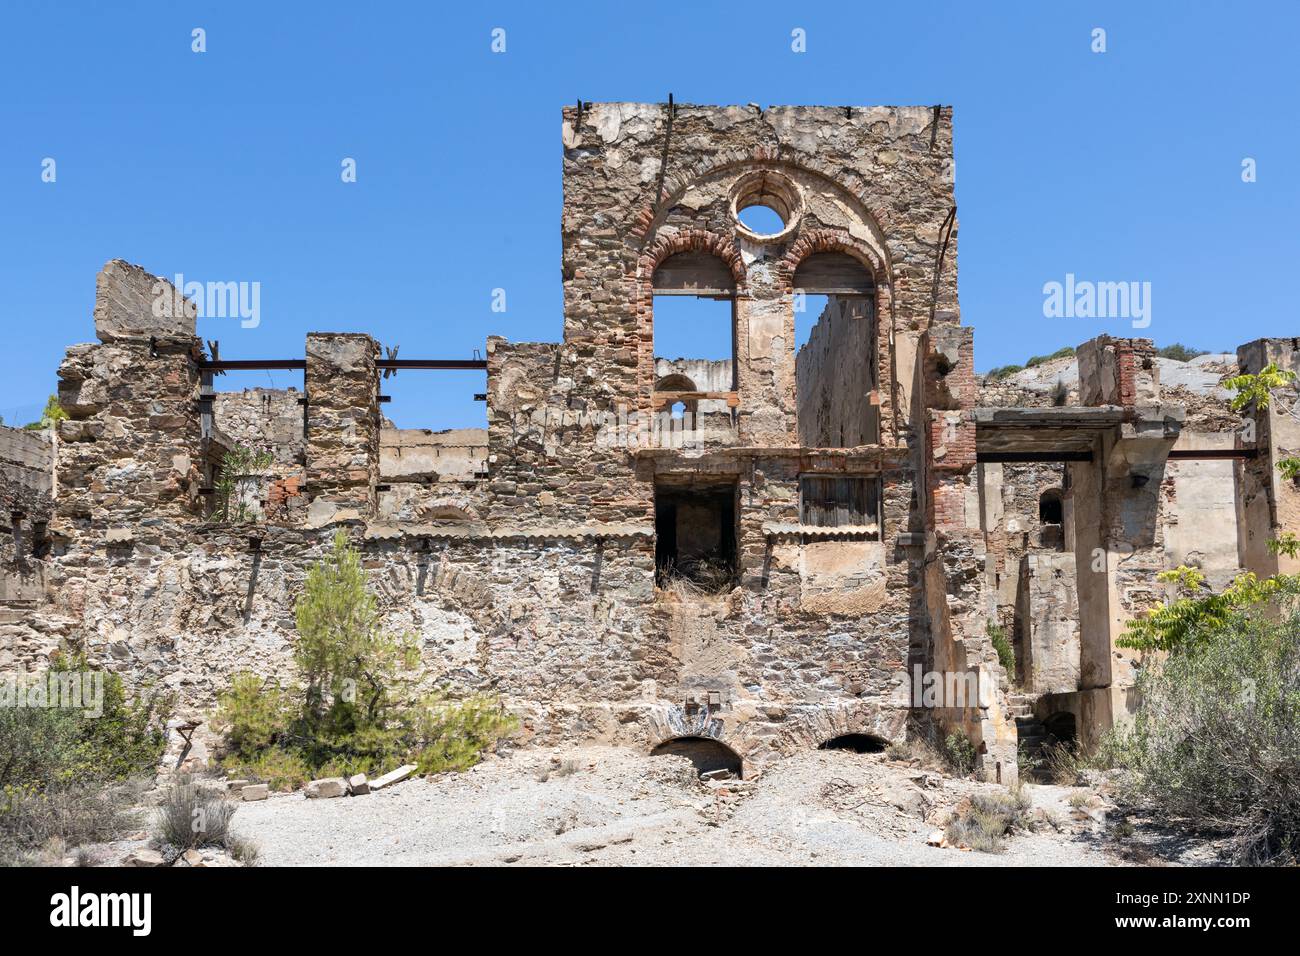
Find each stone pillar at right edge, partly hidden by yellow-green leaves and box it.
[1236,338,1300,576]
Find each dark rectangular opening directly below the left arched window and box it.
[654,483,736,593]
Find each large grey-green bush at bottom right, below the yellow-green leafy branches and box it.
[1106,613,1300,865]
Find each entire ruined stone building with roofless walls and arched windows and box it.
[0,103,1300,782]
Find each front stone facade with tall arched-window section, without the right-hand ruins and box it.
[0,104,1045,783]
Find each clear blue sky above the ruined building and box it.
[0,0,1300,427]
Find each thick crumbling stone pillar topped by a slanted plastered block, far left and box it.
[52,259,202,531]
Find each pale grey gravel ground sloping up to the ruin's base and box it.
[223,748,1149,866]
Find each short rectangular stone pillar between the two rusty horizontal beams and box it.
[306,332,380,527]
